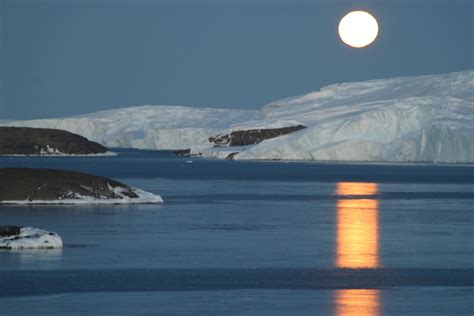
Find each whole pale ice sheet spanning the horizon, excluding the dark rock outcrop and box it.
[2,70,474,163]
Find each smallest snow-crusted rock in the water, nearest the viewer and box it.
[0,226,63,249]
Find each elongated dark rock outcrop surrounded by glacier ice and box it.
[209,125,306,146]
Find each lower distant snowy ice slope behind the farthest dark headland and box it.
[3,105,261,149]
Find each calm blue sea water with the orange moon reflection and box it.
[0,150,474,316]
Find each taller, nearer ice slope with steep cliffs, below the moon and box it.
[233,70,474,163]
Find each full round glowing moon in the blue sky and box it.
[339,11,379,48]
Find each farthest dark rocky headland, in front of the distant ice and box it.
[0,127,108,155]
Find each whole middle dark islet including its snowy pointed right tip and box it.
[0,168,163,204]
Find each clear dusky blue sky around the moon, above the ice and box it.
[0,0,474,119]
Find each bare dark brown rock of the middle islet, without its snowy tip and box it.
[0,168,138,201]
